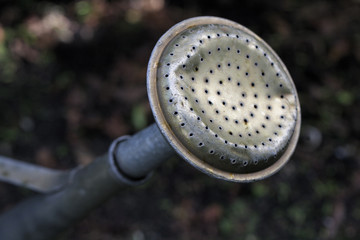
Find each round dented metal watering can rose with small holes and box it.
[147,17,301,182]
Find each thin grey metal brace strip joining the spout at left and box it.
[0,156,71,193]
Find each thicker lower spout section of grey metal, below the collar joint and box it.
[0,156,121,240]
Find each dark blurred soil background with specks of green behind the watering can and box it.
[0,0,360,240]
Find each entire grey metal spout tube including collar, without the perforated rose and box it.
[0,124,174,240]
